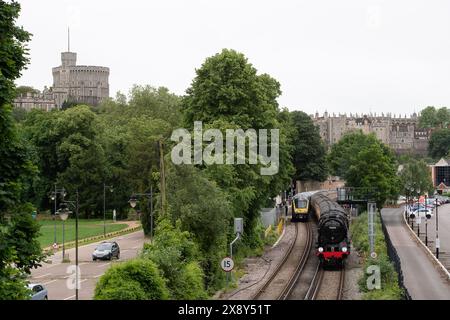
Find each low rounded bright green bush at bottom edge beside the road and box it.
[94,259,169,300]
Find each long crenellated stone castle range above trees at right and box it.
[311,112,431,155]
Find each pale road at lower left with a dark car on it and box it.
[29,230,146,300]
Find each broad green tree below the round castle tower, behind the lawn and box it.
[24,106,108,215]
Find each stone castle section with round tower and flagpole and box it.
[14,43,109,111]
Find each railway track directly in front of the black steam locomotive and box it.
[305,265,345,300]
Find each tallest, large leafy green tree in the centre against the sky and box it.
[182,49,293,247]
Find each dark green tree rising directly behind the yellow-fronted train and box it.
[290,111,327,181]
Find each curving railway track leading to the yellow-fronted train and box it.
[253,222,313,300]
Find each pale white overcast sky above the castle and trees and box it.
[17,0,450,114]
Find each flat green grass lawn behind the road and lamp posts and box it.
[38,219,128,248]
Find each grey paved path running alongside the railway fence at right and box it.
[381,207,450,300]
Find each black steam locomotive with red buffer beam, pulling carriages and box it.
[311,192,350,266]
